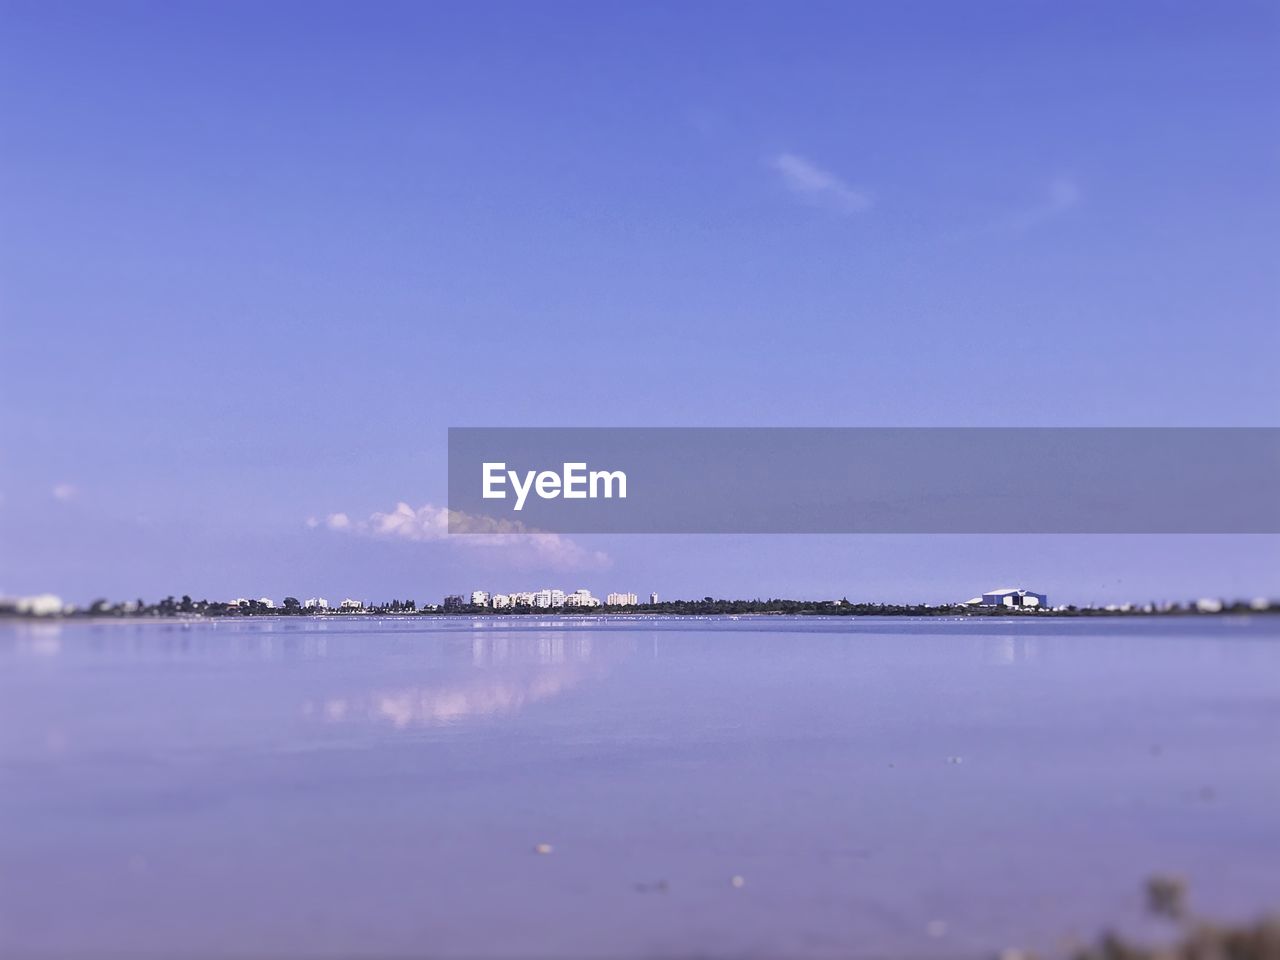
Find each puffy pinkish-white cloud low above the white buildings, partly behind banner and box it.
[307,502,612,571]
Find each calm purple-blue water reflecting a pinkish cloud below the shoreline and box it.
[0,618,1280,957]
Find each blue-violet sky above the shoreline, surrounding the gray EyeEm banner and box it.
[0,0,1280,602]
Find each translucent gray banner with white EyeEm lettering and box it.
[449,428,1280,534]
